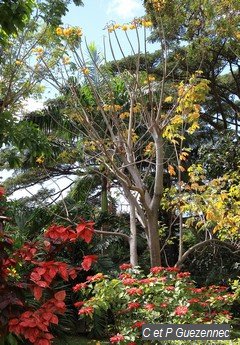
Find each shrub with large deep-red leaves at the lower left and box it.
[0,188,97,345]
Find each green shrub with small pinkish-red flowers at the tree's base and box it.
[74,264,234,345]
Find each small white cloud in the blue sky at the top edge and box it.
[107,0,143,19]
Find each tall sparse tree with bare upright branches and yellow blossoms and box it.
[26,10,213,266]
